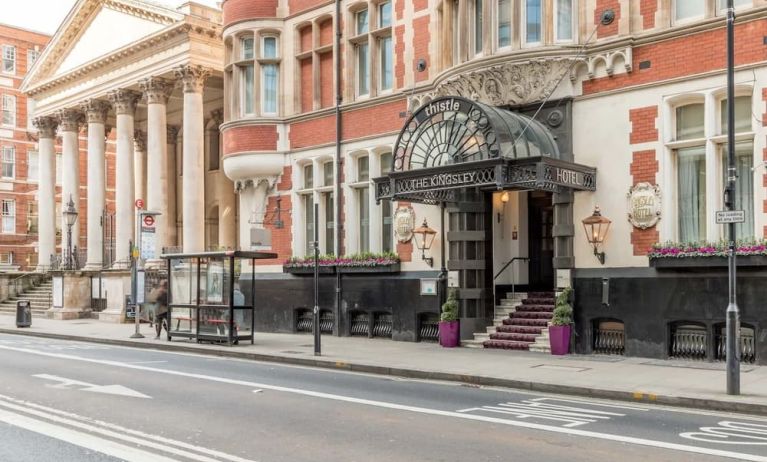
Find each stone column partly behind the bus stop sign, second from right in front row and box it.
[139,77,173,256]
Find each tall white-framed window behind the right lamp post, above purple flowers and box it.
[671,96,755,242]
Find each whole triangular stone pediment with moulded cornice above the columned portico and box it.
[22,0,184,91]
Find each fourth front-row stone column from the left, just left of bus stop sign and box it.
[109,90,141,268]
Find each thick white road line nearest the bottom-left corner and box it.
[0,409,174,462]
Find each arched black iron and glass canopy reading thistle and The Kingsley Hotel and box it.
[373,96,596,203]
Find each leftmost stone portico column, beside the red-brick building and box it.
[32,117,58,271]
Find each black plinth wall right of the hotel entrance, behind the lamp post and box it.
[574,267,767,364]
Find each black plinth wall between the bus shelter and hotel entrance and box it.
[240,272,439,342]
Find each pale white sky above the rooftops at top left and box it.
[0,0,220,35]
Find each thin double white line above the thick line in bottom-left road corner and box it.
[0,395,254,462]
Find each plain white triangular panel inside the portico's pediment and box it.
[52,7,170,76]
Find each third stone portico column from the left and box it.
[81,100,109,270]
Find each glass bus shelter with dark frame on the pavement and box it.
[162,251,277,345]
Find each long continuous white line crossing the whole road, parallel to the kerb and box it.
[0,345,767,462]
